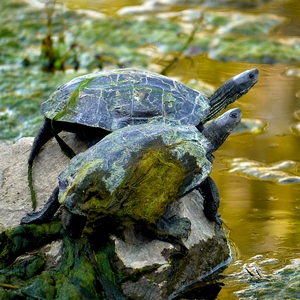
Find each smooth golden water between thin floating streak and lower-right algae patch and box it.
[214,174,300,258]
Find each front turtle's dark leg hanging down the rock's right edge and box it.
[197,177,222,225]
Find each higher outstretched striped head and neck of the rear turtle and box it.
[203,69,259,123]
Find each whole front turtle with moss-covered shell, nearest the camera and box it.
[21,108,241,239]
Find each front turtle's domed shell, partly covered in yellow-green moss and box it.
[58,124,212,218]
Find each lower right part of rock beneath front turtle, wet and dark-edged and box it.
[112,190,231,300]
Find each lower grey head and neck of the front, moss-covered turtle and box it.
[202,108,242,154]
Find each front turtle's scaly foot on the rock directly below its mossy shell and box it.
[156,215,191,239]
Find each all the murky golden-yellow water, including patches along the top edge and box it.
[1,0,300,299]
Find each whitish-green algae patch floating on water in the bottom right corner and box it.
[217,249,300,299]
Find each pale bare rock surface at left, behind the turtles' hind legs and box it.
[0,134,85,232]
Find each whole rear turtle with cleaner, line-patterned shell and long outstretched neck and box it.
[28,68,259,209]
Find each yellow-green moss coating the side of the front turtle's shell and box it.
[60,146,186,234]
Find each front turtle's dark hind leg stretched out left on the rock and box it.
[20,187,60,224]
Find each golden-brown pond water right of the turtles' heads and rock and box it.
[168,55,300,299]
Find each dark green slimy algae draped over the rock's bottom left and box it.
[0,232,122,300]
